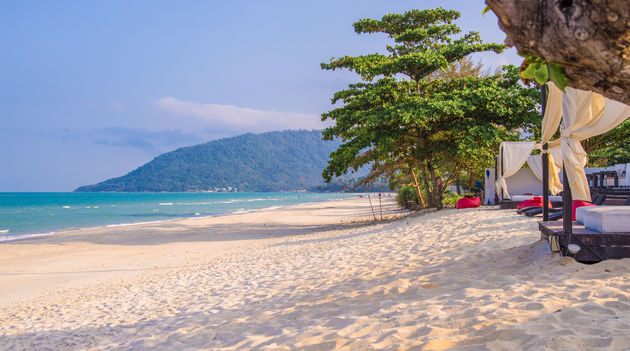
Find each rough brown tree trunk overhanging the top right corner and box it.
[486,0,630,105]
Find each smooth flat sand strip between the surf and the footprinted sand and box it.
[0,198,404,309]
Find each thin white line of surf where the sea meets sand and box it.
[0,193,380,245]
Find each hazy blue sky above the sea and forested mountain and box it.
[0,0,520,191]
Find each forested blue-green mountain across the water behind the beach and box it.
[75,130,350,192]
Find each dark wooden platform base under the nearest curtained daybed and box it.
[538,221,630,263]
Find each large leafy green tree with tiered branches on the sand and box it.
[322,8,538,208]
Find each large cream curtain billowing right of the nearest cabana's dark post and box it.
[564,87,630,201]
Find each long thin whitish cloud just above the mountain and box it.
[156,97,328,132]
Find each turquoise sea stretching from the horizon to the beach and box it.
[0,193,355,242]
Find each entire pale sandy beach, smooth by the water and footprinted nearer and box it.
[0,199,630,350]
